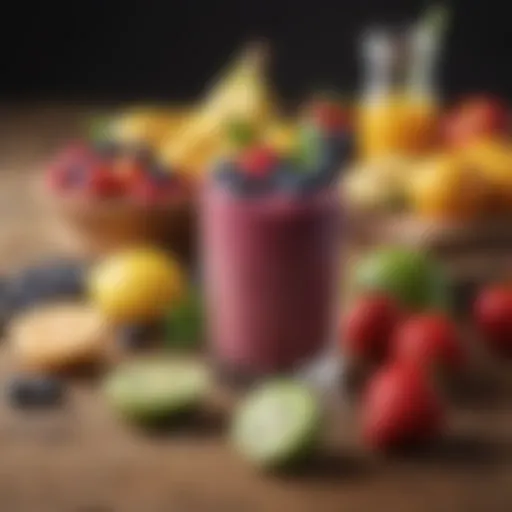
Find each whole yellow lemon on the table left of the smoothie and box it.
[89,248,186,323]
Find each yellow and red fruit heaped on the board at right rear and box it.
[345,96,512,221]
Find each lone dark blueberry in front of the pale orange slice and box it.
[7,376,64,408]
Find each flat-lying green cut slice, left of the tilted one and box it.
[104,360,208,423]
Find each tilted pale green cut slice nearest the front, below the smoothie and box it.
[232,380,322,468]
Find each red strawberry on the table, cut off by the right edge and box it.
[473,285,512,357]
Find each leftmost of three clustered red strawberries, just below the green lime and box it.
[342,295,402,362]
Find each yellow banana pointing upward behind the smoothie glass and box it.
[161,45,274,174]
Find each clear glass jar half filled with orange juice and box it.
[358,18,439,159]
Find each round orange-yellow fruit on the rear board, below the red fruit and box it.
[409,155,489,219]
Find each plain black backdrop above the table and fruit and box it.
[0,0,512,101]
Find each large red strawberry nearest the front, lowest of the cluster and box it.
[361,363,443,450]
